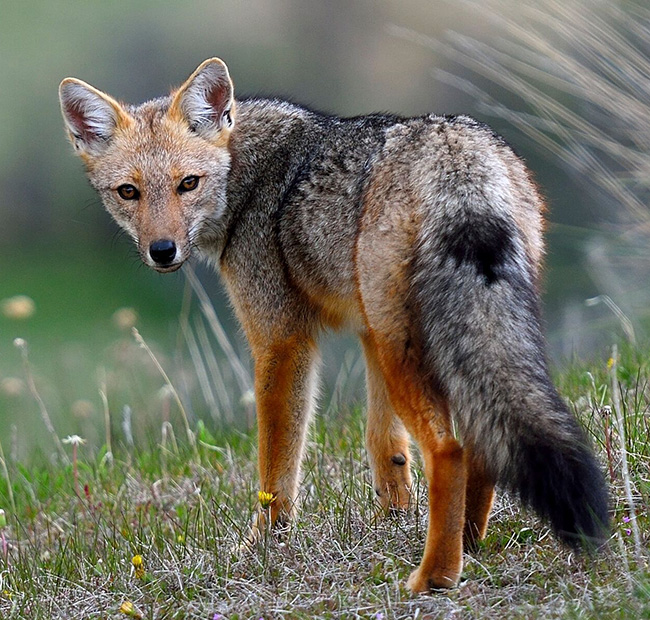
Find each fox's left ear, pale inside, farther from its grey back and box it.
[59,78,131,156]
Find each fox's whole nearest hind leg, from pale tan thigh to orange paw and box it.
[356,188,467,592]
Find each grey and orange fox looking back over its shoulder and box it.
[59,58,609,593]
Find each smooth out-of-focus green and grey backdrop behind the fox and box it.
[0,0,645,456]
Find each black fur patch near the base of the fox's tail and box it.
[440,217,515,286]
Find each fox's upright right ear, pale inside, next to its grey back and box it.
[169,58,235,141]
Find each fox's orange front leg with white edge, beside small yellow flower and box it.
[253,334,317,536]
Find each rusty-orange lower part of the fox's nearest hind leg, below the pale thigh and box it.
[354,283,467,592]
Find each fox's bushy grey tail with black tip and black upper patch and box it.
[412,192,608,545]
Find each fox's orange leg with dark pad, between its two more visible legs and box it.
[361,334,411,510]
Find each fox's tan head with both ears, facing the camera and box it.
[59,58,235,272]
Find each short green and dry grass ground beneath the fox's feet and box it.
[0,336,650,620]
